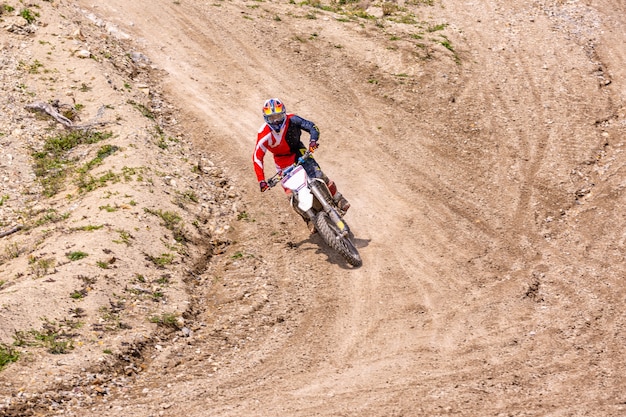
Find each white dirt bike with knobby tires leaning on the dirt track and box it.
[268,151,363,267]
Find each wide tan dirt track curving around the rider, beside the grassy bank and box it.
[3,0,626,417]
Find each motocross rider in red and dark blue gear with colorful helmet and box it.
[252,98,350,223]
